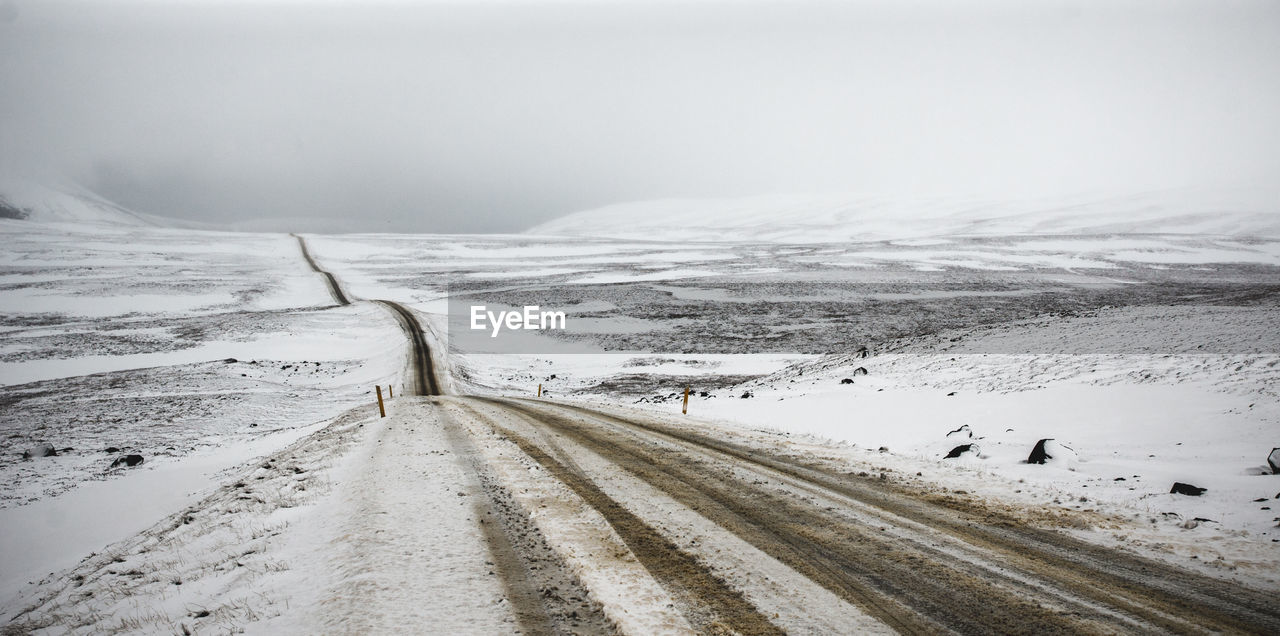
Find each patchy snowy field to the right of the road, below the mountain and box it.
[294,223,1280,582]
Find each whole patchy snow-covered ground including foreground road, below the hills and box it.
[0,186,1280,633]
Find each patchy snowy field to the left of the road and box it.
[0,221,406,606]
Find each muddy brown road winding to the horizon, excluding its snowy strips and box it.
[298,237,1280,633]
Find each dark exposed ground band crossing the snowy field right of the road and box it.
[451,265,1280,354]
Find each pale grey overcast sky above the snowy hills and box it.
[0,0,1280,232]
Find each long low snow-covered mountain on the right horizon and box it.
[527,189,1280,243]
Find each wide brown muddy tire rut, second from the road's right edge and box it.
[483,403,1126,633]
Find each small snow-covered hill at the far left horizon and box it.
[0,178,163,225]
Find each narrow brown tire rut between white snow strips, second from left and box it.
[458,402,783,636]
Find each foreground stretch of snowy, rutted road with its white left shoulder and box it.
[9,397,1280,633]
